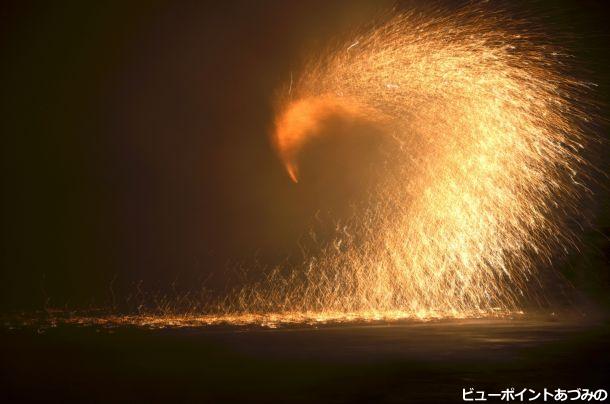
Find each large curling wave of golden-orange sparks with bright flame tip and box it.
[255,3,589,324]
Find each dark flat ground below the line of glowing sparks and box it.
[0,320,610,403]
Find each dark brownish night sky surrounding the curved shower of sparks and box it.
[0,0,610,310]
